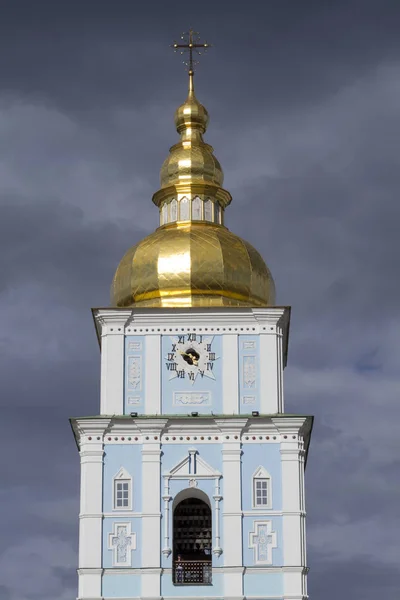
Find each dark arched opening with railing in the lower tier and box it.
[173,497,212,585]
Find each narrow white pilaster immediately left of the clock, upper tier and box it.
[145,335,162,415]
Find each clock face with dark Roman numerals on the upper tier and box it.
[165,333,219,384]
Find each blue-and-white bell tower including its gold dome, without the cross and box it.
[71,35,312,600]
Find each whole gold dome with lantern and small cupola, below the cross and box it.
[111,71,275,308]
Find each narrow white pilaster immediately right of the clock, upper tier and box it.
[222,334,239,415]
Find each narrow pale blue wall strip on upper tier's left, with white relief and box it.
[124,335,146,414]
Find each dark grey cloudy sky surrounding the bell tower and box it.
[0,0,400,600]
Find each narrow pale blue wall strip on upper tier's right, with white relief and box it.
[238,335,260,414]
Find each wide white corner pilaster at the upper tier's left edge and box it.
[100,317,125,415]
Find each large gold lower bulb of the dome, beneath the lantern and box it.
[112,222,275,307]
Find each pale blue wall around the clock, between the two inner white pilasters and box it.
[161,335,222,414]
